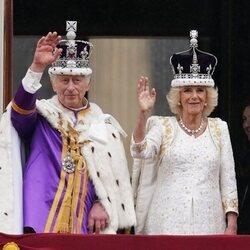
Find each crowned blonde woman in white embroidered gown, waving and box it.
[131,31,238,235]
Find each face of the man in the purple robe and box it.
[52,75,90,109]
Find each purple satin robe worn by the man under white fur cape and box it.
[11,84,96,233]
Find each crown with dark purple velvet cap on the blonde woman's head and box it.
[170,30,217,87]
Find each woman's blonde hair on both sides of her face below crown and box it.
[166,87,218,117]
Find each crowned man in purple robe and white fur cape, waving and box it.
[8,22,135,233]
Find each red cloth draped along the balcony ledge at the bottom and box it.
[0,234,250,250]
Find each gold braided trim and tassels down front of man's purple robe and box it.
[45,117,88,233]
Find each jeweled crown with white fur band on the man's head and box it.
[49,21,93,75]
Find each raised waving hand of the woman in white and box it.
[137,76,156,112]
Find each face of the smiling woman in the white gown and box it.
[180,86,207,115]
